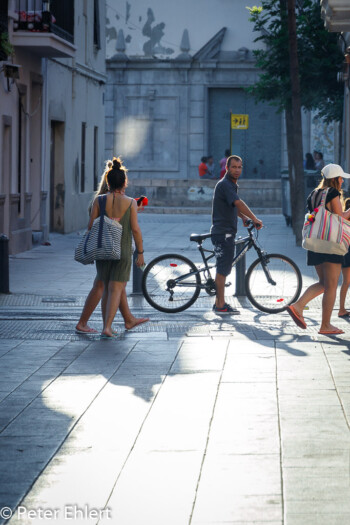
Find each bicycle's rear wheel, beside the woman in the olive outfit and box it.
[142,254,201,313]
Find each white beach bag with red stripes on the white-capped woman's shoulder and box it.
[302,189,350,255]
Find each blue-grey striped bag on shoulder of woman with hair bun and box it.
[74,195,123,264]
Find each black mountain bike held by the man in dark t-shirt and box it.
[142,223,302,313]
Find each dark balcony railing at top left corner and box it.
[13,0,74,44]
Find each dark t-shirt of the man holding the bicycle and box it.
[210,173,239,235]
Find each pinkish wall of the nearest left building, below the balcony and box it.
[0,40,42,248]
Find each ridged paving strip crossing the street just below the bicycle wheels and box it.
[0,309,310,341]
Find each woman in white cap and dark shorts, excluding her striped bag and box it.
[287,164,350,335]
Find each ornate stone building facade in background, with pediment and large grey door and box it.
[105,0,282,180]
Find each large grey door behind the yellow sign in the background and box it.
[208,88,281,179]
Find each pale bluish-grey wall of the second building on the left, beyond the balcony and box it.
[45,0,106,233]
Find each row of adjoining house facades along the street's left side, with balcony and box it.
[0,0,106,253]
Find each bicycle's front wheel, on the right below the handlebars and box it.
[245,253,302,314]
